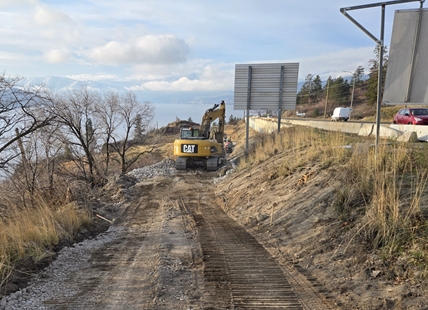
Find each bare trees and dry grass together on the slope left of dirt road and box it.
[0,74,163,293]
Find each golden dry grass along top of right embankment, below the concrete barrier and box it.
[238,127,428,277]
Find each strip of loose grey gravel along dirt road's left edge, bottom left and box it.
[0,226,123,310]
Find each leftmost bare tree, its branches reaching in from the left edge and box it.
[0,74,55,168]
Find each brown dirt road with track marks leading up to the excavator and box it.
[2,172,338,309]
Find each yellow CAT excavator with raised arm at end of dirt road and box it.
[174,101,226,171]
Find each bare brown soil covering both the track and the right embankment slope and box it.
[0,123,428,310]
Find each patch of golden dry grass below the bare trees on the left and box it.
[0,188,90,284]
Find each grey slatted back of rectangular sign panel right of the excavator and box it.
[233,63,299,110]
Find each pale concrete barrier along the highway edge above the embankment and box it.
[249,117,428,142]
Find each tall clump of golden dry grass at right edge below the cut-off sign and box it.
[366,145,428,255]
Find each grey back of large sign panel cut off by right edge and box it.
[383,9,428,105]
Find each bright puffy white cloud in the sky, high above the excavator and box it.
[88,35,189,65]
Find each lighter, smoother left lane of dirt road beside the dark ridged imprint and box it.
[44,180,203,310]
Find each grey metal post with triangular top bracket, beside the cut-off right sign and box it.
[340,0,425,151]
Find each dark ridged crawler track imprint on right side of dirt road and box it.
[177,178,329,310]
